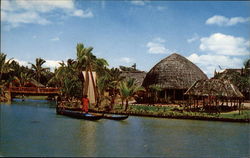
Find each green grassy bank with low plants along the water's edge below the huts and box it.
[92,105,250,123]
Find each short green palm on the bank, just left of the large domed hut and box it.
[120,78,144,111]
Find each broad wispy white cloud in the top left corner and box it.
[1,0,93,28]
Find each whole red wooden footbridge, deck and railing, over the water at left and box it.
[9,87,60,96]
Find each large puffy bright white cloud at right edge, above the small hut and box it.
[200,33,250,56]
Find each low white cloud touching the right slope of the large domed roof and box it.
[187,53,243,77]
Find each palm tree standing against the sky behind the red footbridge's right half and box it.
[29,58,49,83]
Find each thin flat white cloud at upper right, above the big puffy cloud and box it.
[206,15,250,26]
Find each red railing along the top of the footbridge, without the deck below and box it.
[10,87,60,94]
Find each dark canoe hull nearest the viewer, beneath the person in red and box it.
[57,109,102,121]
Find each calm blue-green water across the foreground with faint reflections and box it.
[0,100,250,157]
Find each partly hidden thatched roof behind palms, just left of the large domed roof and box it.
[121,71,147,86]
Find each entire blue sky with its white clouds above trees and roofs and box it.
[1,0,250,77]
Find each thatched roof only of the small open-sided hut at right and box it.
[185,79,244,98]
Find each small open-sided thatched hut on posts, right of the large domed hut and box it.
[185,79,244,110]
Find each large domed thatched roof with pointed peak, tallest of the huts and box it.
[142,53,207,89]
